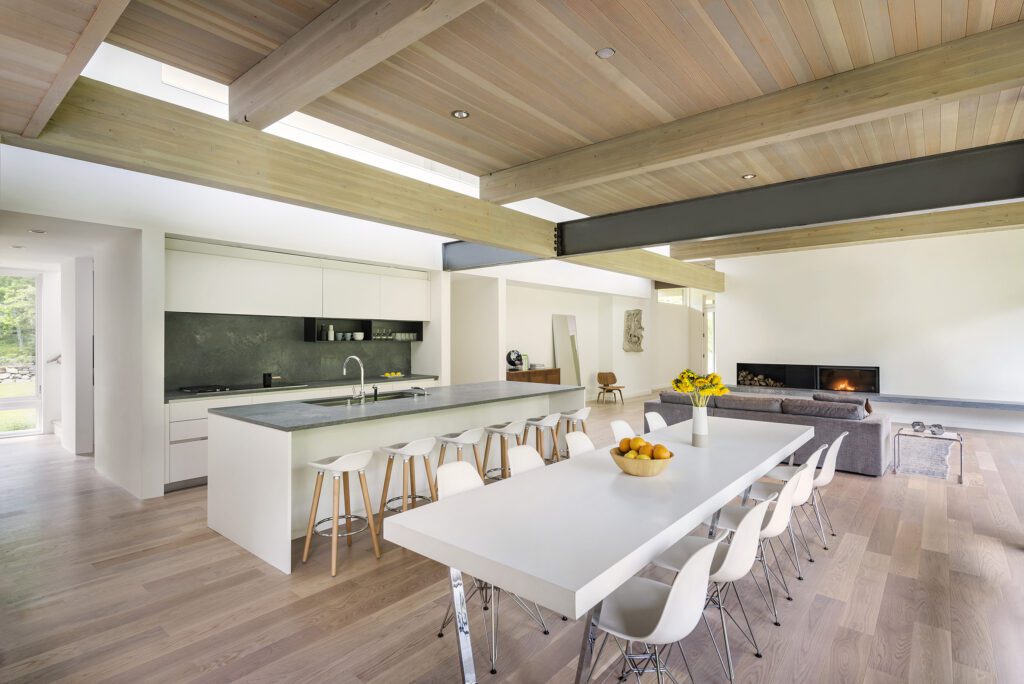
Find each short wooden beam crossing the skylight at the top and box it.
[228,0,483,129]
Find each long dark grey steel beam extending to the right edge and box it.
[558,140,1024,256]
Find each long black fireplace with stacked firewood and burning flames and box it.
[736,364,882,394]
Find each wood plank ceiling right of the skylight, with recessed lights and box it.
[103,0,1024,215]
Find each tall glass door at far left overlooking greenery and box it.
[0,270,41,437]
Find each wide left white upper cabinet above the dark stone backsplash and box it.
[166,250,323,316]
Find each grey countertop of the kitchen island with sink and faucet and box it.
[210,382,584,432]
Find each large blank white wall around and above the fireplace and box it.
[717,230,1024,401]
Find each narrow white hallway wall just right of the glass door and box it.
[60,257,93,454]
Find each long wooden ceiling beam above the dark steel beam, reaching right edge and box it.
[480,22,1024,204]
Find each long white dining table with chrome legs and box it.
[384,418,814,682]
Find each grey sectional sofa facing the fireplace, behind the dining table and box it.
[644,392,891,477]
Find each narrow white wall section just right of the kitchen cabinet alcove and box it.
[452,275,505,385]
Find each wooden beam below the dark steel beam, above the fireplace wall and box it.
[671,202,1024,260]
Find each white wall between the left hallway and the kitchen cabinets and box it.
[94,231,164,499]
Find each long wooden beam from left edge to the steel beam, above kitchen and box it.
[2,78,555,257]
